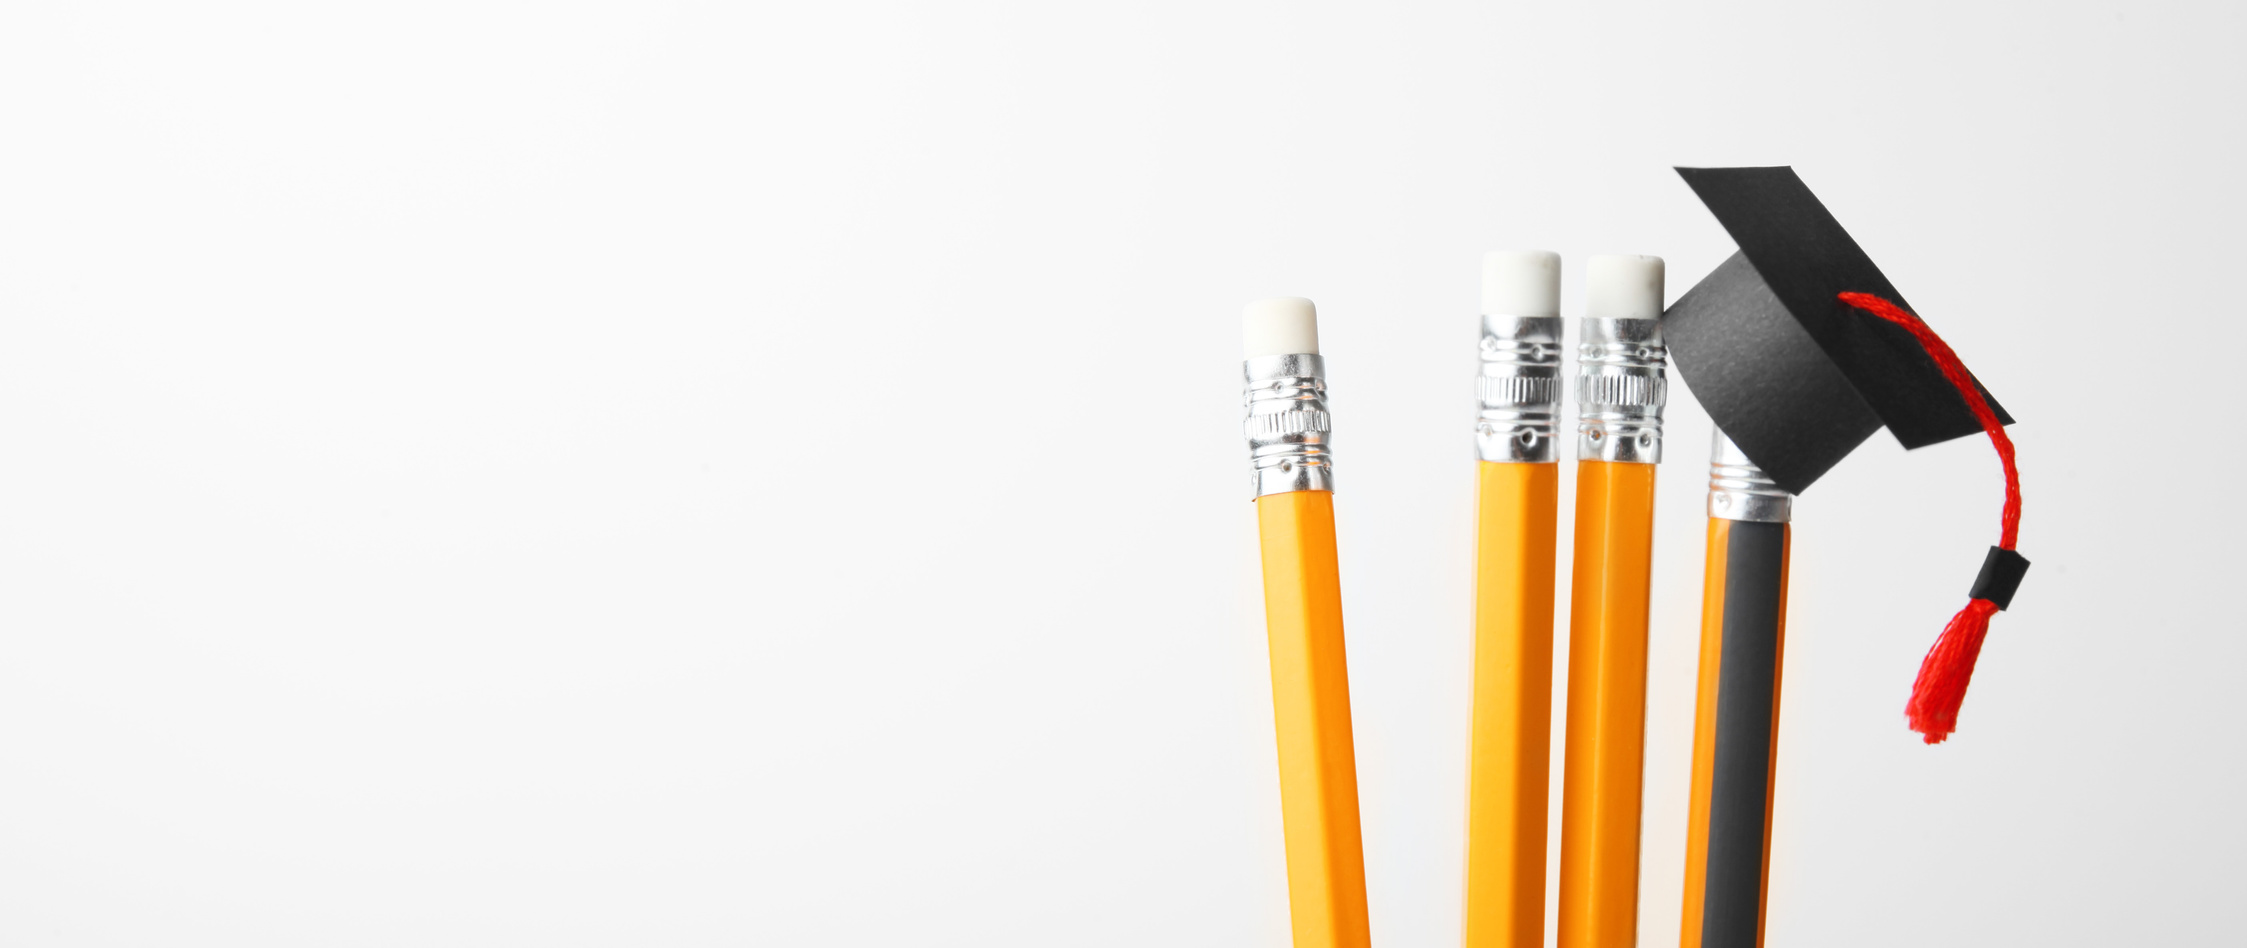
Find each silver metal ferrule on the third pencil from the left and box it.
[1575,319,1670,465]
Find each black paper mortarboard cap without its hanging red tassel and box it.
[1663,168,2013,494]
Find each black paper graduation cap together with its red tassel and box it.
[1663,168,2029,744]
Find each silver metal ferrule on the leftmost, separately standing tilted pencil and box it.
[1240,353,1335,496]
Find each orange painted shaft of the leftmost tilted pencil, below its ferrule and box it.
[1256,490,1371,948]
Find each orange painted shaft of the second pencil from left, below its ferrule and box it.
[1465,461,1559,948]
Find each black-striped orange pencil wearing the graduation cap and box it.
[1679,431,1793,948]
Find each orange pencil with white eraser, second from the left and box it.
[1465,252,1562,948]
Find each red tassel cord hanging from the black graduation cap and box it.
[1840,292,2020,744]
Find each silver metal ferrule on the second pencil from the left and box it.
[1474,315,1562,463]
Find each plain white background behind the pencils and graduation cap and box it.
[0,2,2247,948]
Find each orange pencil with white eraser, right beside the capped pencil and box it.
[1555,256,1667,948]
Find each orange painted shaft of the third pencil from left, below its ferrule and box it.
[1555,461,1654,948]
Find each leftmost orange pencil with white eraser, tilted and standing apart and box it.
[1243,299,1371,948]
